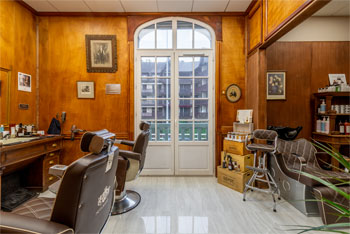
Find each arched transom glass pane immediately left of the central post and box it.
[157,21,173,49]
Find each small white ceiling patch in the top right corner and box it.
[314,0,350,16]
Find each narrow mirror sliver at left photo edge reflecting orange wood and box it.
[0,67,11,125]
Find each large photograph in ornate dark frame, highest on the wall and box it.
[85,35,117,73]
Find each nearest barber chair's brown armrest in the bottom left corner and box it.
[0,211,74,234]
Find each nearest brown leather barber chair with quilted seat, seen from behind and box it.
[0,130,118,233]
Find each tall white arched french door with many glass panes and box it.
[134,17,215,175]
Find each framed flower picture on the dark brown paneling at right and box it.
[266,71,286,100]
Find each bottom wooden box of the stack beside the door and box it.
[217,166,253,193]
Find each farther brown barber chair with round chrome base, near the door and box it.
[112,122,150,215]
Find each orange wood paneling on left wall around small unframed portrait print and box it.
[0,1,36,124]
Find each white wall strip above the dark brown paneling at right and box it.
[278,16,350,41]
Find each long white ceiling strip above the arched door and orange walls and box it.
[23,0,252,12]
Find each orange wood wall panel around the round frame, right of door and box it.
[215,17,246,173]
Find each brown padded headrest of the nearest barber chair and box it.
[80,129,115,154]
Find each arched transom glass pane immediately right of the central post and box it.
[176,21,193,49]
